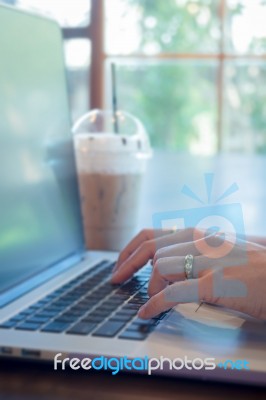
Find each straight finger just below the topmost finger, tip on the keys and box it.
[111,240,156,283]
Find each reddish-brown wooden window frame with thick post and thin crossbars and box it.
[63,0,266,152]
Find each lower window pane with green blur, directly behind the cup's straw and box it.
[106,60,217,154]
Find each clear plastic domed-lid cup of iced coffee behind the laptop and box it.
[73,110,151,251]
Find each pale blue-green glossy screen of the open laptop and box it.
[0,6,83,293]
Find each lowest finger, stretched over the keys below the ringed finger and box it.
[138,273,217,319]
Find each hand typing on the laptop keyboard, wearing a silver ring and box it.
[112,228,266,319]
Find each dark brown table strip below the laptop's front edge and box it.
[0,360,266,400]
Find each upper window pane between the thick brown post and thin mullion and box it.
[105,0,220,55]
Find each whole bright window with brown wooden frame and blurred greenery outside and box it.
[0,0,266,154]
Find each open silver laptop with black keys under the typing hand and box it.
[0,2,266,384]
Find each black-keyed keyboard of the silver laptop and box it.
[0,260,168,340]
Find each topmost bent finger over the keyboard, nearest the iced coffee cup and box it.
[113,229,172,272]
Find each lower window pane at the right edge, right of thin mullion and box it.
[224,61,266,153]
